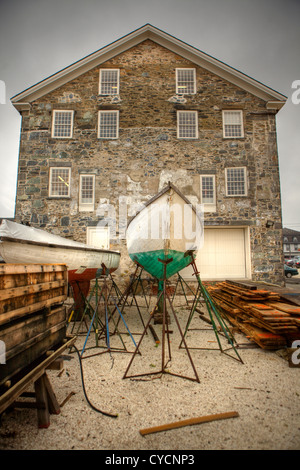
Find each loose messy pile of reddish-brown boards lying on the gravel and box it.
[206,281,300,349]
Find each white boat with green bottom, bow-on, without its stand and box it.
[126,182,203,281]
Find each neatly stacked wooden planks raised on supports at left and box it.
[0,264,68,394]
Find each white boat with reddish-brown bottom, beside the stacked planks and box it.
[0,219,120,308]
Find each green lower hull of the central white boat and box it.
[129,250,195,281]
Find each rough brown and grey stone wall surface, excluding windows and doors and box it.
[16,40,283,283]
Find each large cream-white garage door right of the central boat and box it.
[181,228,247,280]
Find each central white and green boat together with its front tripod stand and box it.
[124,182,203,382]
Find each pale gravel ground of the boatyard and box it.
[0,296,300,451]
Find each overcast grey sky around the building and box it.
[0,0,300,231]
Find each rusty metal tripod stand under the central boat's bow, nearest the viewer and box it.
[123,258,200,382]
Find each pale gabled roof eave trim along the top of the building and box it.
[11,24,287,109]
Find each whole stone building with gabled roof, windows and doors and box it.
[12,24,286,283]
